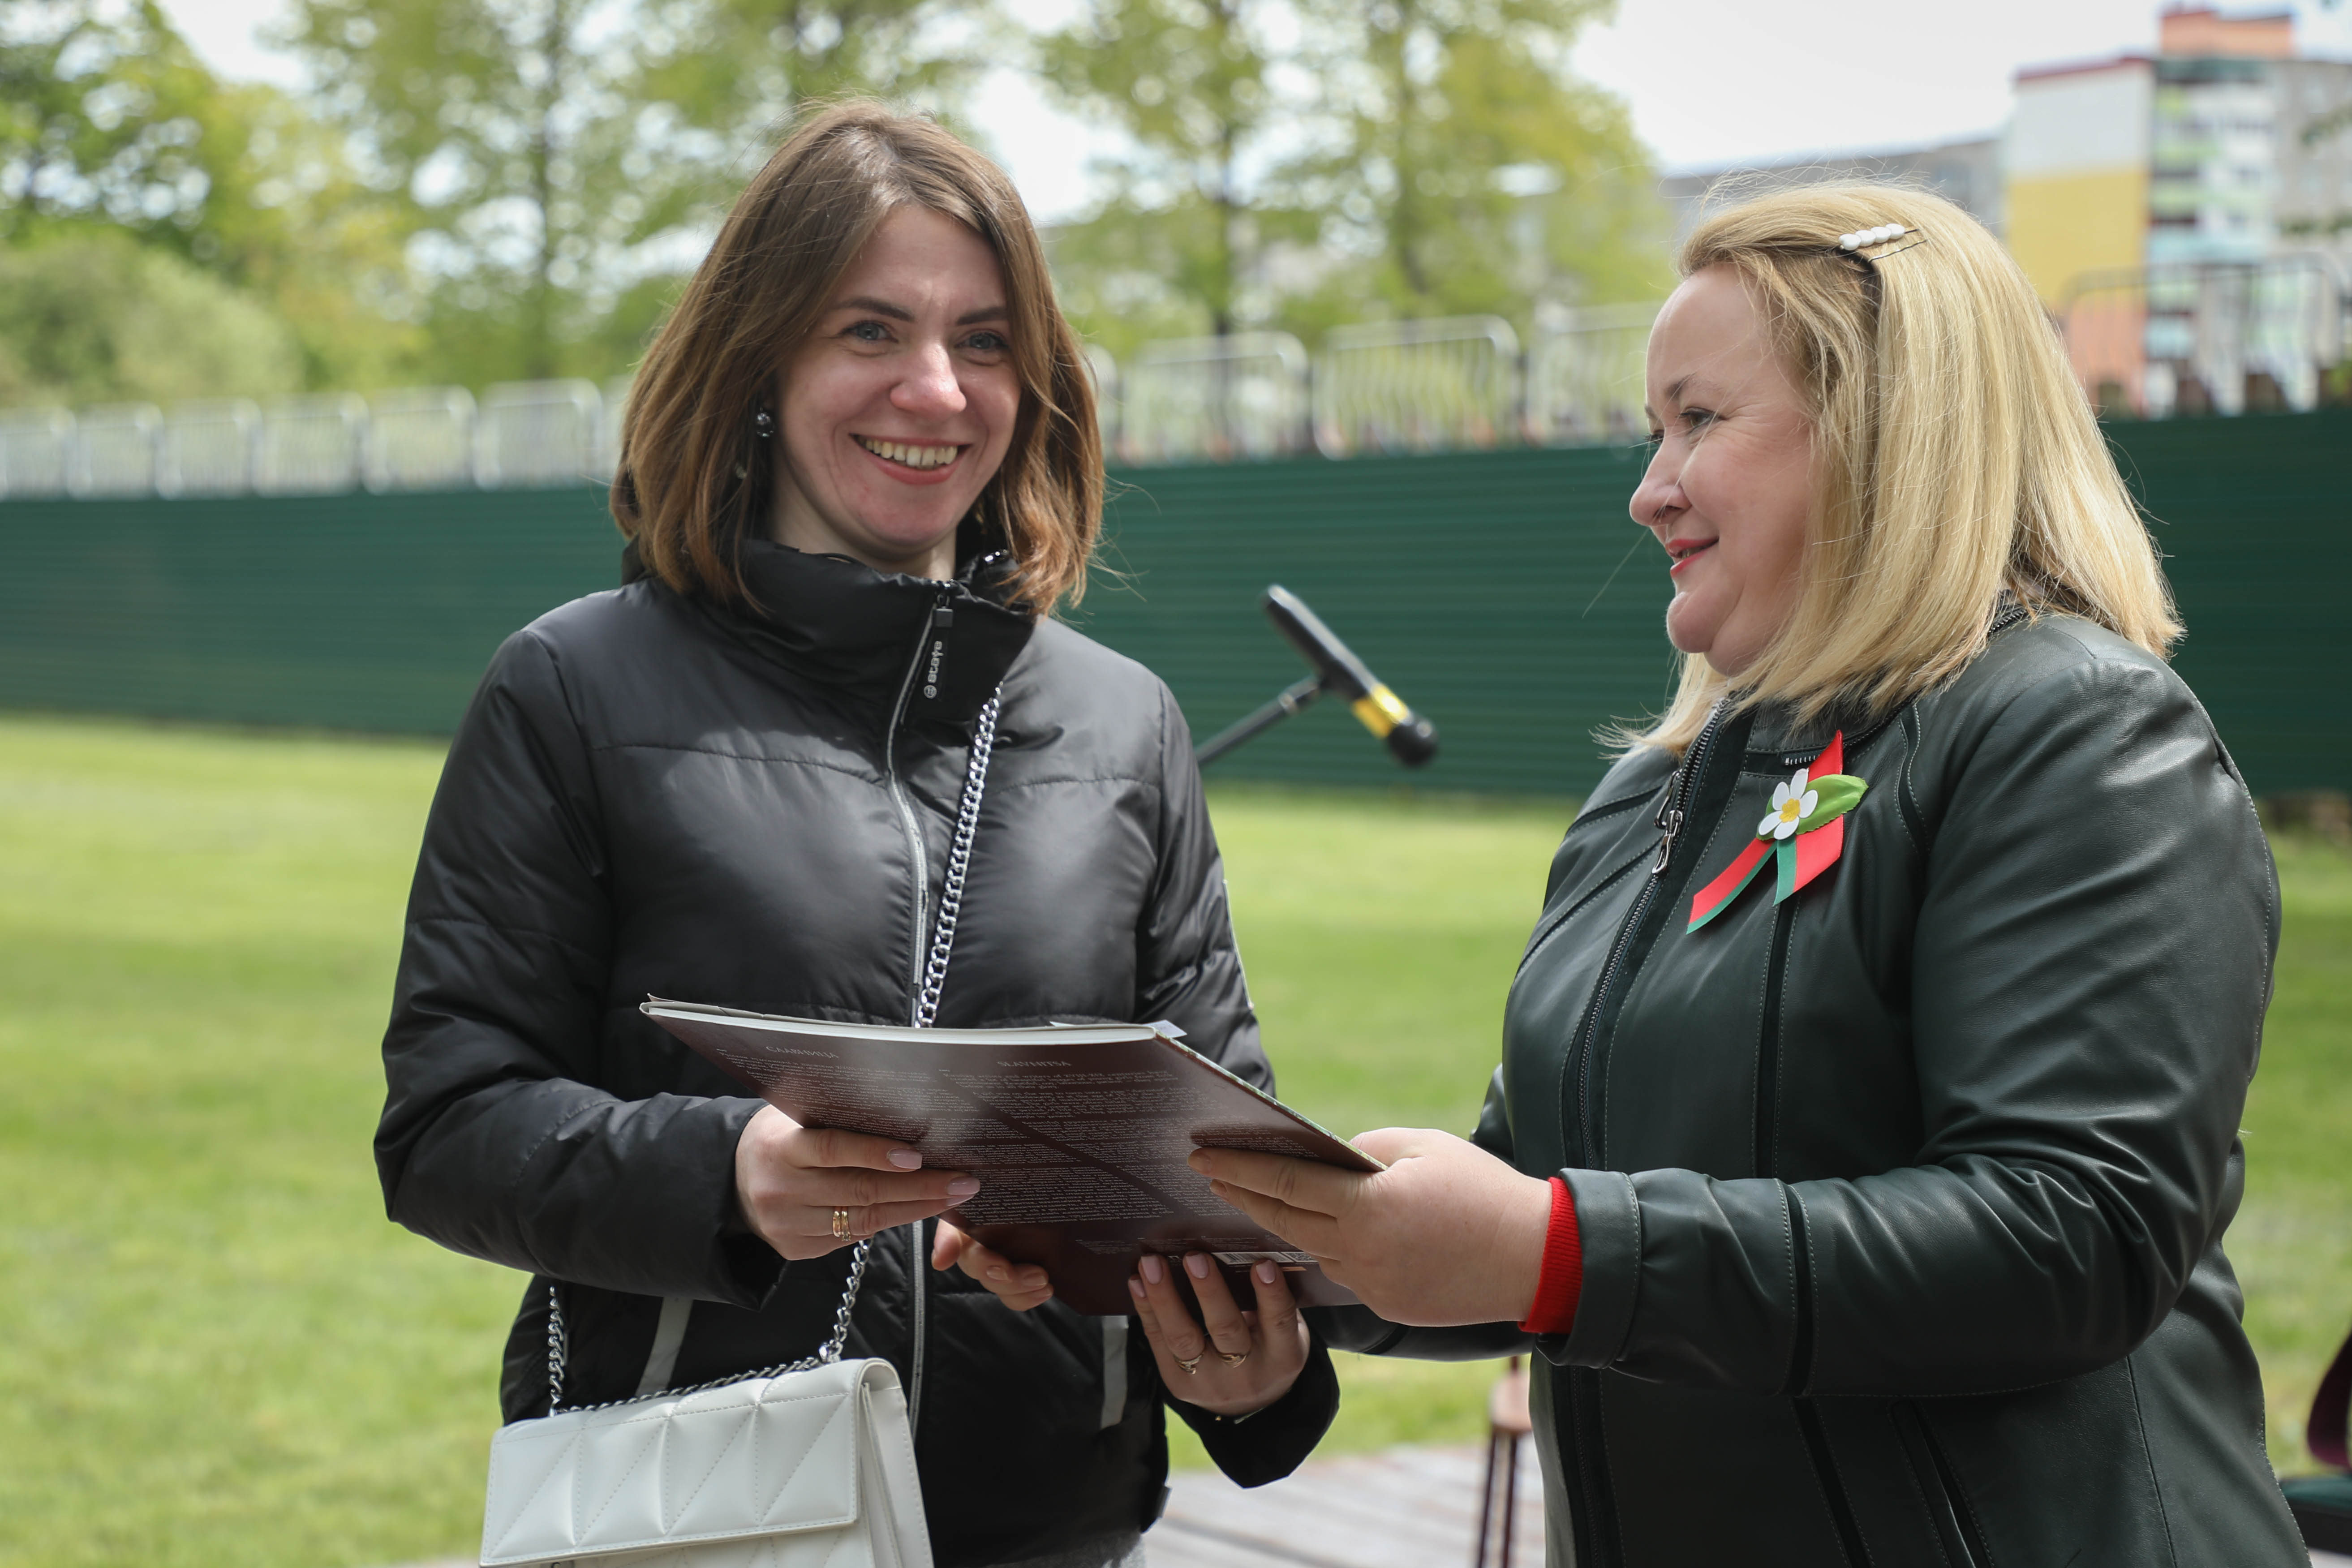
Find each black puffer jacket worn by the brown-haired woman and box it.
[376,543,1338,1568]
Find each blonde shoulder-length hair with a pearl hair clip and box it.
[1616,183,2180,752]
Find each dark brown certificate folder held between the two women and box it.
[640,997,1380,1316]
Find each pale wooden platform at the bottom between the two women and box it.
[1143,1443,1543,1568]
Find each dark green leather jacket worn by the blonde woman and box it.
[1345,616,2307,1568]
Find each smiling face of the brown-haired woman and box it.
[771,207,1021,578]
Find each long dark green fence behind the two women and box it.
[0,412,2352,795]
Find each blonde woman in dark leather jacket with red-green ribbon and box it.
[1197,186,2305,1568]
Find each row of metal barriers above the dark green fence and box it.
[0,266,2352,498]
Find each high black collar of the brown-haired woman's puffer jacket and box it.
[623,538,1037,724]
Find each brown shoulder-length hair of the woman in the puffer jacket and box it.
[611,99,1103,614]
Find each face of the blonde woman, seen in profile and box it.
[1630,266,1814,674]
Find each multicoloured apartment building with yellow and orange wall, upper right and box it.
[2004,4,2352,414]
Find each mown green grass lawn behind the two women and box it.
[0,719,2352,1568]
